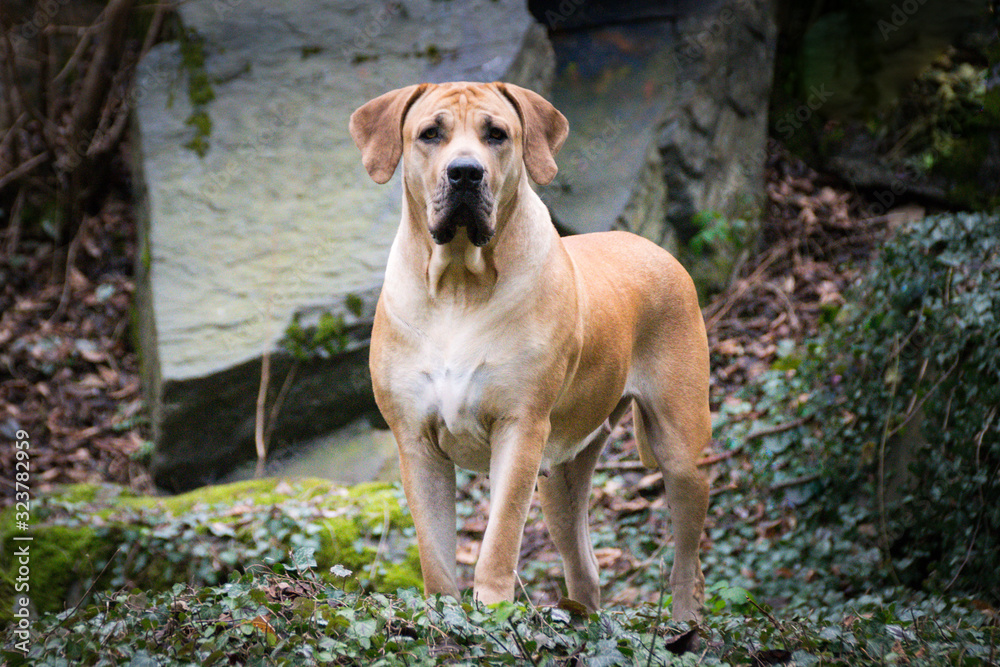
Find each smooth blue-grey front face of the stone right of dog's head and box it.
[540,19,678,247]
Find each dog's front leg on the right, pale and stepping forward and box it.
[475,419,549,604]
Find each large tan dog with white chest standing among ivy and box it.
[350,83,711,620]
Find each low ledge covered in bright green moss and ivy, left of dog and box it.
[0,479,420,624]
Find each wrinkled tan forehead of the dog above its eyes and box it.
[404,82,520,130]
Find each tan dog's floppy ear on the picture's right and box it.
[496,82,569,185]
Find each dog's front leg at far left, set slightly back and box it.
[397,436,459,600]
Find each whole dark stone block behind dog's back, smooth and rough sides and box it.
[532,0,777,282]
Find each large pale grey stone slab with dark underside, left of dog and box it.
[134,0,553,490]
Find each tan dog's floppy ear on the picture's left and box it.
[348,83,427,183]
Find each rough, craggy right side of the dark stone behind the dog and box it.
[658,0,778,241]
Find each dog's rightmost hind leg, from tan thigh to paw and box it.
[633,364,712,623]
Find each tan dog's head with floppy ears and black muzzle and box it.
[350,82,569,246]
